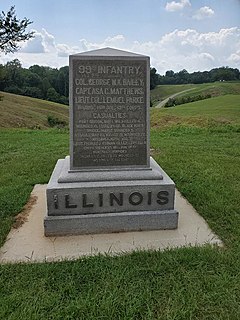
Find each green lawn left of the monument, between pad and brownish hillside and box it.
[0,129,69,245]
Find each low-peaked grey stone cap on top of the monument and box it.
[72,47,147,58]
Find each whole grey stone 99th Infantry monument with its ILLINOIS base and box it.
[44,48,178,236]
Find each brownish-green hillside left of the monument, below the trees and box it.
[0,92,68,129]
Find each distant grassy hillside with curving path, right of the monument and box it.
[151,82,240,106]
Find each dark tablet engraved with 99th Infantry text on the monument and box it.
[72,59,147,168]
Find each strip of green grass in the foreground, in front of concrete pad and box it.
[0,247,240,320]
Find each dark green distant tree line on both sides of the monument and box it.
[0,59,240,105]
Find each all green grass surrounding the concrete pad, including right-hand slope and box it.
[0,86,240,320]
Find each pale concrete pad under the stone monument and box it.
[0,185,222,263]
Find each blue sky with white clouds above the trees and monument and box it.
[0,0,240,74]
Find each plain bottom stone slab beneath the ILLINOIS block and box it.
[44,210,178,236]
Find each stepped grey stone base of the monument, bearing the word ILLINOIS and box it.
[44,157,178,236]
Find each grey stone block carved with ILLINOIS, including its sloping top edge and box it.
[47,160,175,216]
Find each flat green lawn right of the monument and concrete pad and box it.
[151,126,240,246]
